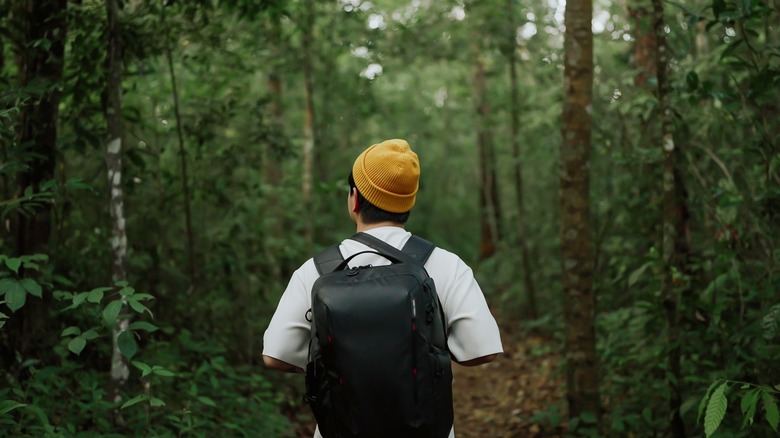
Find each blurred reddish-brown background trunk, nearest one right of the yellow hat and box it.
[474,48,501,260]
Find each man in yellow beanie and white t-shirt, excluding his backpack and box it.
[263,139,503,438]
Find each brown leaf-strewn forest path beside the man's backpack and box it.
[288,320,565,438]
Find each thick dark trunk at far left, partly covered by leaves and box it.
[0,0,67,370]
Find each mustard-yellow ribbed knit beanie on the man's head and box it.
[352,139,420,213]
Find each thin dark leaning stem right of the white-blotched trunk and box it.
[160,6,197,286]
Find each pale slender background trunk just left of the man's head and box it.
[301,0,315,247]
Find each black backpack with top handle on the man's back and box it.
[304,233,453,438]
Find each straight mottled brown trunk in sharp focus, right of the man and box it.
[560,0,600,418]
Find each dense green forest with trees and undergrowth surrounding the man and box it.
[0,0,780,438]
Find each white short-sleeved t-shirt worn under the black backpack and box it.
[263,227,504,438]
